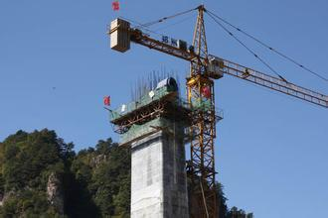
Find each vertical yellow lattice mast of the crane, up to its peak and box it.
[187,5,217,217]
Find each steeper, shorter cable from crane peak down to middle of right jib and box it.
[207,13,289,83]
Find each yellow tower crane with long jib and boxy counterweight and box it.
[108,5,328,218]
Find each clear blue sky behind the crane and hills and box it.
[0,0,328,218]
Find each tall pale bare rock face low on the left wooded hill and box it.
[47,173,64,214]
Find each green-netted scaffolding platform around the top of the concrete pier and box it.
[110,82,223,146]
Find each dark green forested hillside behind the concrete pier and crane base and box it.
[0,129,247,218]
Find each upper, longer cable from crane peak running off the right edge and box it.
[206,10,328,82]
